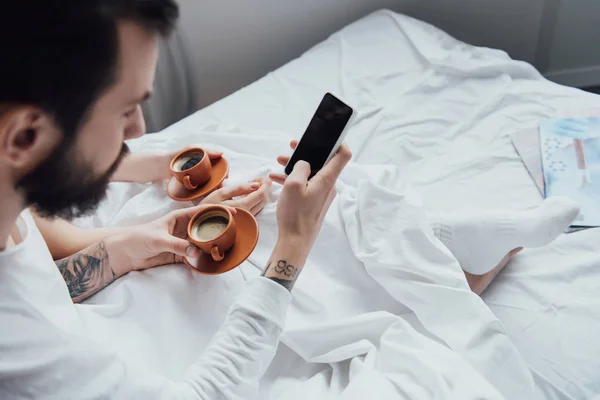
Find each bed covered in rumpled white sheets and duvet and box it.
[77,10,600,400]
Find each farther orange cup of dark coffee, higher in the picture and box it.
[170,147,212,190]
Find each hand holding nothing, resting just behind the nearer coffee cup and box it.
[201,178,271,215]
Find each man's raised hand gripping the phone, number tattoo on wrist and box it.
[262,141,352,290]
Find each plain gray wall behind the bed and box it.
[179,0,600,106]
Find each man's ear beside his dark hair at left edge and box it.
[0,107,61,177]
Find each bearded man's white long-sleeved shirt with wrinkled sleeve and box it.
[0,211,291,400]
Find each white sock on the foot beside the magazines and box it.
[431,197,579,275]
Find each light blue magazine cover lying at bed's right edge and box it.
[540,117,600,227]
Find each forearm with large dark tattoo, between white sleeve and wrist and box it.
[56,242,115,303]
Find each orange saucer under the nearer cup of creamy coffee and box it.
[183,208,258,275]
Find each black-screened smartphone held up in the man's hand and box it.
[285,93,354,179]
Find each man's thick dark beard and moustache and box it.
[17,143,129,219]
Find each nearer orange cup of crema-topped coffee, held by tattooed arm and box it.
[188,205,237,261]
